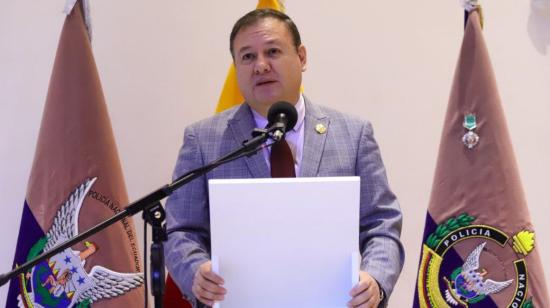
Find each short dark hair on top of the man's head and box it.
[229,9,302,58]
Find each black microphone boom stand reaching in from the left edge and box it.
[0,127,278,307]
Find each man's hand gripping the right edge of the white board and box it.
[348,271,380,308]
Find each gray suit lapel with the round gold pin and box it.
[300,97,330,177]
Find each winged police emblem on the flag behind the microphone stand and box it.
[18,178,143,307]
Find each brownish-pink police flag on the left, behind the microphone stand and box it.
[7,3,144,307]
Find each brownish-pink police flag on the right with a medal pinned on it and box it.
[414,11,550,308]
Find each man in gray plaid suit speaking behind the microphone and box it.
[165,10,404,307]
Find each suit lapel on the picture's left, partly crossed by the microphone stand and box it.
[228,103,271,178]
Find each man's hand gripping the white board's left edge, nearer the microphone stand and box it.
[191,261,227,306]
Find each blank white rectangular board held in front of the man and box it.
[209,177,360,308]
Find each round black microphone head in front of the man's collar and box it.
[267,101,298,141]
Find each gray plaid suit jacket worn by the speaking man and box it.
[165,98,404,300]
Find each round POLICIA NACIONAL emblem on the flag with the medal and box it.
[417,213,534,308]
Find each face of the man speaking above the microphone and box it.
[233,18,306,116]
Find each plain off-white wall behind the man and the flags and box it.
[0,0,550,307]
